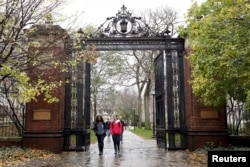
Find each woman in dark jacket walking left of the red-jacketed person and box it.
[94,115,106,155]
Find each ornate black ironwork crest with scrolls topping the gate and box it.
[94,5,157,38]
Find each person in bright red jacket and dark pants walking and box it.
[109,115,122,154]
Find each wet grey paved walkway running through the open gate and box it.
[7,131,207,167]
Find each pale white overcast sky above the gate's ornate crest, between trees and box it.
[61,0,205,27]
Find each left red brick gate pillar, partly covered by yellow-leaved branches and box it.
[23,25,66,153]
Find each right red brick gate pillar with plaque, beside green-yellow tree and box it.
[184,39,228,150]
